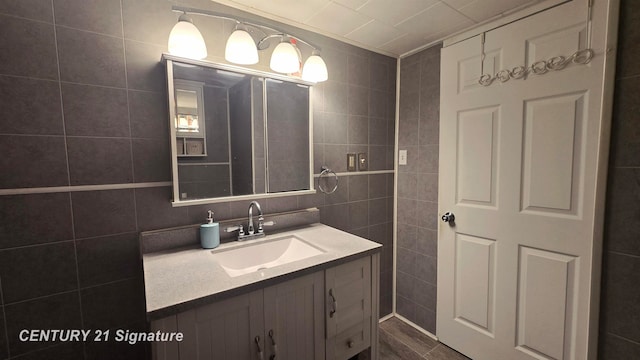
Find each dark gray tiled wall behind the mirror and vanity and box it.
[0,0,396,359]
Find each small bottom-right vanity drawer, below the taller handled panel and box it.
[327,318,371,360]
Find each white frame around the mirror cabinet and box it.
[162,54,316,207]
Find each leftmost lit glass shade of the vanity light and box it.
[169,15,207,59]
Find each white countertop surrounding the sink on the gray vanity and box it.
[142,224,382,320]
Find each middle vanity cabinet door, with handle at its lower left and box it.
[264,272,325,360]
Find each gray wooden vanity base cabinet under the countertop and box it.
[151,254,379,360]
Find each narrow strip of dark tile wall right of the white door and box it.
[598,0,640,360]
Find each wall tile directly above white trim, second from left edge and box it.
[67,137,133,185]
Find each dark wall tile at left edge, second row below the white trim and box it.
[0,241,78,304]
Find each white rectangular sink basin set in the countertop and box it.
[212,235,325,277]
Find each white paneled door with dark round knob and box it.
[436,0,617,360]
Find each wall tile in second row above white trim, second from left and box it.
[58,83,130,137]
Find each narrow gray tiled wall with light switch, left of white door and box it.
[396,46,441,334]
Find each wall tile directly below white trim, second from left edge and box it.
[71,189,137,239]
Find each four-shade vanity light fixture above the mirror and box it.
[169,6,328,82]
